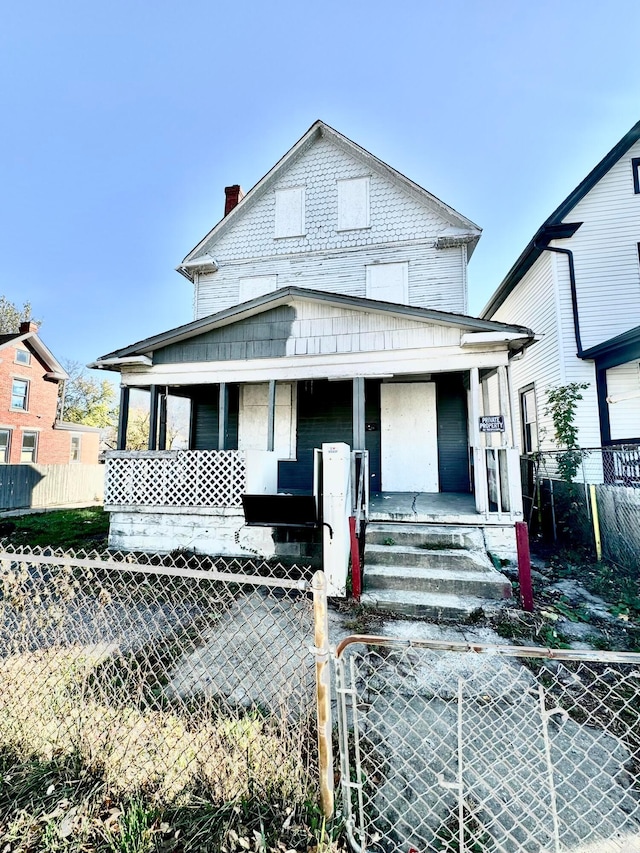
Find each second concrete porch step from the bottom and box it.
[364,565,511,600]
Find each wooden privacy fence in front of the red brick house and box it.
[0,463,104,511]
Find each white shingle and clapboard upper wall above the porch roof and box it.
[196,133,466,317]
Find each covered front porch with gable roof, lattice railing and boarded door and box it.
[95,288,532,553]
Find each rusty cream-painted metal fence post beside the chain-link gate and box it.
[311,572,333,820]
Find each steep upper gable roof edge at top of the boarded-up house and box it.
[176,119,482,280]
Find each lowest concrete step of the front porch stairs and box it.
[360,589,500,622]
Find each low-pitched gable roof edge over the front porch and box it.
[89,287,533,369]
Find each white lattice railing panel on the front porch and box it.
[104,450,246,507]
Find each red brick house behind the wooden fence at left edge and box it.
[0,321,100,465]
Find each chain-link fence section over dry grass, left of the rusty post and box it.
[0,548,317,808]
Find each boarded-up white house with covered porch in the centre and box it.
[93,121,532,572]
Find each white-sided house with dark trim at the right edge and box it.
[482,122,640,460]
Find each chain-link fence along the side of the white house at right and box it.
[522,445,640,569]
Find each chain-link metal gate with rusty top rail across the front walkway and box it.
[335,637,640,853]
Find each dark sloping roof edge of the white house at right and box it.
[480,121,640,317]
